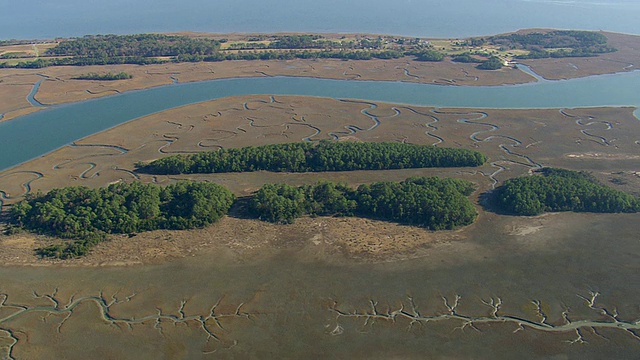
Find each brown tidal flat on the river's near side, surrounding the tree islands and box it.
[0,96,640,359]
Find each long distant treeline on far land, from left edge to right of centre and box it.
[0,34,452,69]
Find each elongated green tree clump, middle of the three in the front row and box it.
[249,177,477,230]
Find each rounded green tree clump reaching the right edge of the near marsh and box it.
[493,168,640,215]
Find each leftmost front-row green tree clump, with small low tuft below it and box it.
[9,182,234,258]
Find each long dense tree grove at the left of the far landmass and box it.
[47,34,220,58]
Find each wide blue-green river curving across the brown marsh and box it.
[0,71,640,170]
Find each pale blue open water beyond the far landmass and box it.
[0,0,640,39]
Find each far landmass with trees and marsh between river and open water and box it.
[0,29,640,120]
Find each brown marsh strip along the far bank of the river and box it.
[5,30,640,121]
